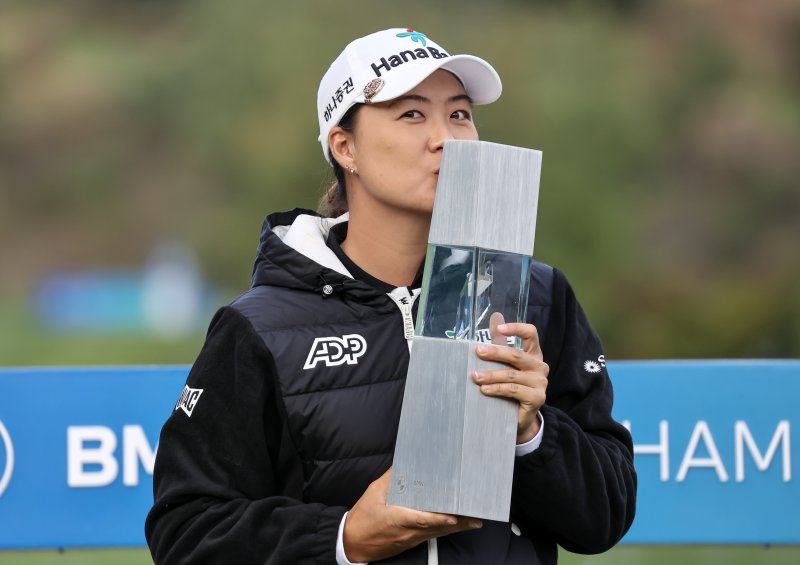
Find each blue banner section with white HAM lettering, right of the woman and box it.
[609,361,800,544]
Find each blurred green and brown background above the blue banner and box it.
[0,0,800,562]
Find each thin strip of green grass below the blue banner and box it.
[0,545,800,565]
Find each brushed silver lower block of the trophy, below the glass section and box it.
[388,336,518,521]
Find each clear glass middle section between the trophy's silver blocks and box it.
[415,245,531,347]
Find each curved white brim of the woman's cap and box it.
[368,55,503,108]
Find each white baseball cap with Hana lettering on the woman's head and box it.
[317,28,503,162]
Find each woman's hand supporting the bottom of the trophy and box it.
[342,468,483,563]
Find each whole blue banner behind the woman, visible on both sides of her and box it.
[0,361,800,548]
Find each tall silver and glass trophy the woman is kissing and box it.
[387,141,542,521]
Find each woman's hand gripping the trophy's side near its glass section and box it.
[472,313,550,444]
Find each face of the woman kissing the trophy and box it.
[347,69,478,215]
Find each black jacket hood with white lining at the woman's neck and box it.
[251,208,385,300]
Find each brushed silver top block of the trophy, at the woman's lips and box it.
[428,140,542,255]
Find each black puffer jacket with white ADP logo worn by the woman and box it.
[145,210,636,565]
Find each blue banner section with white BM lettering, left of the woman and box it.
[0,367,188,548]
